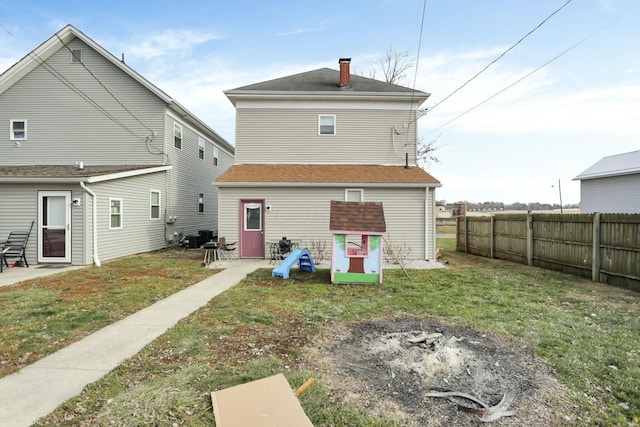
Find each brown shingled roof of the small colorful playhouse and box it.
[329,200,387,233]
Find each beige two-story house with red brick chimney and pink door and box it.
[215,58,440,259]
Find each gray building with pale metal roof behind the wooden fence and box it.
[574,151,640,214]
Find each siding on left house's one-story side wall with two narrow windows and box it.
[91,172,166,261]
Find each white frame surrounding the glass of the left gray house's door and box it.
[37,190,71,263]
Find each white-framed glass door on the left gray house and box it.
[38,191,71,263]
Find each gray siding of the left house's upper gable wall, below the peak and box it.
[0,39,165,165]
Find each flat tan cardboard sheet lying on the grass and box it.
[211,374,313,427]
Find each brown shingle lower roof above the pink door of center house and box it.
[215,164,440,184]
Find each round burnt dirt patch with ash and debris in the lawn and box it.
[303,319,575,426]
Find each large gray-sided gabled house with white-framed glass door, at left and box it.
[0,25,234,265]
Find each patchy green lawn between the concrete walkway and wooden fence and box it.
[8,246,640,426]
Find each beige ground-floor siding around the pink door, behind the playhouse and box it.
[218,187,434,259]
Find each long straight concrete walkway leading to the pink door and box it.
[0,260,273,427]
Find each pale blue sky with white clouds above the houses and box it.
[0,0,640,203]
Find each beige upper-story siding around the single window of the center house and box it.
[236,108,416,165]
